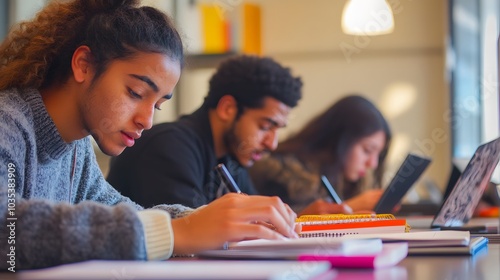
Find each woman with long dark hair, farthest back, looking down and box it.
[250,95,391,214]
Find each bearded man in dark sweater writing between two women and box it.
[107,55,352,217]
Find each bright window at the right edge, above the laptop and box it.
[449,0,500,159]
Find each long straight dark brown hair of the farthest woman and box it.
[274,95,391,198]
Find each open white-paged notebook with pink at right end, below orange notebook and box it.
[198,237,408,270]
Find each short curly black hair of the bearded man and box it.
[204,55,302,114]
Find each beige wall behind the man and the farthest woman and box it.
[178,0,451,199]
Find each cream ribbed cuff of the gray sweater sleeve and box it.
[137,209,174,260]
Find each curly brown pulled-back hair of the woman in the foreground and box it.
[0,0,183,90]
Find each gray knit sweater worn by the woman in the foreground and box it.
[0,90,191,271]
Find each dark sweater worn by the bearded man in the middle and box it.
[107,104,255,207]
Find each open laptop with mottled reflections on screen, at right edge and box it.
[407,138,500,232]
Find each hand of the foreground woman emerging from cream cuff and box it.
[172,193,298,254]
